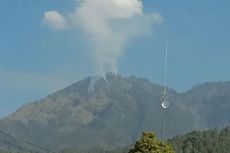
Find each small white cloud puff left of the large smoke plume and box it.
[43,11,66,30]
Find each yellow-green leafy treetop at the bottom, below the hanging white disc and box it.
[128,132,174,153]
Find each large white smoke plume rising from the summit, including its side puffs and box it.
[44,0,162,75]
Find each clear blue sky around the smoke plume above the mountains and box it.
[0,0,230,117]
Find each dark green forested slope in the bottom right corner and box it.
[170,127,230,153]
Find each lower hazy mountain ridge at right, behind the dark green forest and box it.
[182,81,230,128]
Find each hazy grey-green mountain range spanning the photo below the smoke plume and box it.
[0,74,230,152]
